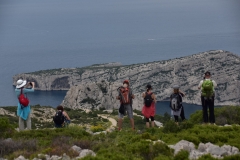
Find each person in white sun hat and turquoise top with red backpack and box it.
[15,79,35,131]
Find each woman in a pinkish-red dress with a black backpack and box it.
[142,84,157,128]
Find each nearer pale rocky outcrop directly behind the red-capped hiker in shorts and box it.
[61,80,143,110]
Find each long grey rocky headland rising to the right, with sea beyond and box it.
[13,50,240,108]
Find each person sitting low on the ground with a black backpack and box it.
[53,105,71,128]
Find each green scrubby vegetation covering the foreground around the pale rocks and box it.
[0,107,240,160]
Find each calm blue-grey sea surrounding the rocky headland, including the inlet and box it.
[0,0,240,117]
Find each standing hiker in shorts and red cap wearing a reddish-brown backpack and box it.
[117,80,135,131]
